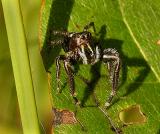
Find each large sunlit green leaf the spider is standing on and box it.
[41,0,160,134]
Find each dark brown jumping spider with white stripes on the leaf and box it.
[51,22,120,107]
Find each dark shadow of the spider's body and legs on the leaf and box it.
[81,25,150,107]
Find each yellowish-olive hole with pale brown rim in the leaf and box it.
[119,105,147,125]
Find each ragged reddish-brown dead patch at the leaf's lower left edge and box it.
[53,108,77,125]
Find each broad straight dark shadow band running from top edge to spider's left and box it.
[41,0,74,71]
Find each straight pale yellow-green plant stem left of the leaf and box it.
[1,0,40,134]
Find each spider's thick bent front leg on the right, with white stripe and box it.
[103,48,121,107]
